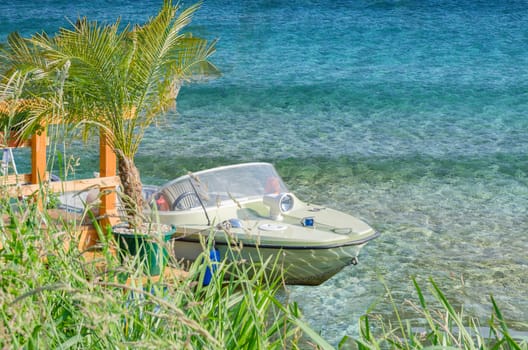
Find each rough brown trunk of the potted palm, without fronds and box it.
[117,152,144,228]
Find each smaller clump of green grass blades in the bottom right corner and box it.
[350,278,528,350]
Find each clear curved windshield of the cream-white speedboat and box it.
[160,163,288,210]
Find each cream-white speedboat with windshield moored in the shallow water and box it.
[144,163,379,285]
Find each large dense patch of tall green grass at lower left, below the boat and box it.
[0,197,331,349]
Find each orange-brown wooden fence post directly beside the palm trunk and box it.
[99,129,117,226]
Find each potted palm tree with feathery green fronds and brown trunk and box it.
[0,0,218,226]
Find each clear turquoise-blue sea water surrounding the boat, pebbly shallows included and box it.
[0,0,528,345]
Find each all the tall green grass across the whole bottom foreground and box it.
[0,196,528,350]
